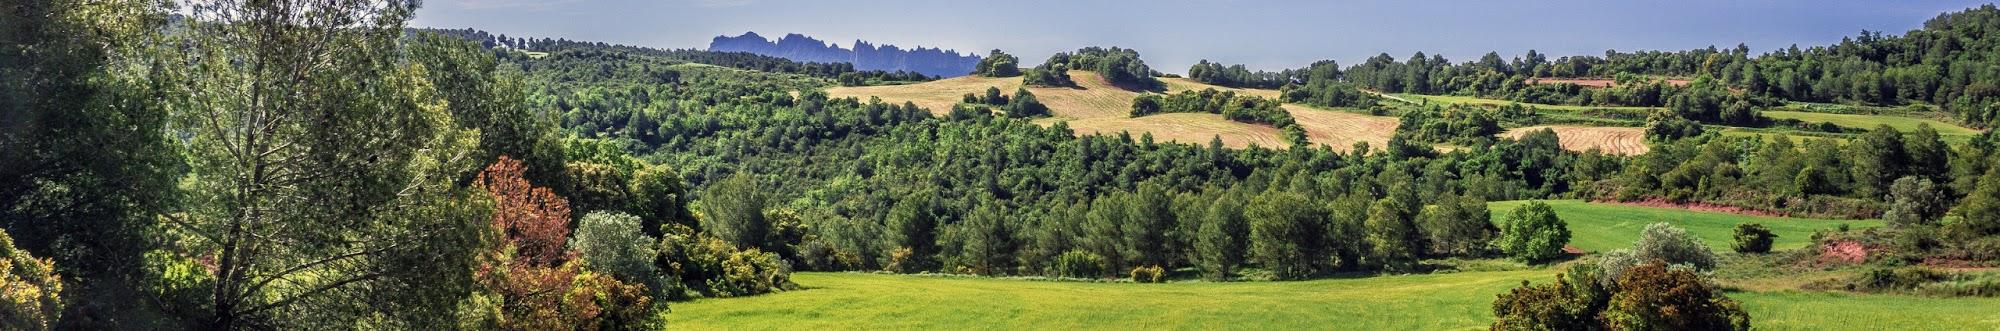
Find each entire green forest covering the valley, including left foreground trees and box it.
[0,0,2000,329]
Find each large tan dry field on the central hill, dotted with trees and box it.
[826,70,1396,150]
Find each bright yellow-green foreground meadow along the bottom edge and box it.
[666,269,2000,329]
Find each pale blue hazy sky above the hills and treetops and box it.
[414,0,1990,74]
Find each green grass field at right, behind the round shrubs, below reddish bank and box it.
[1486,199,1882,251]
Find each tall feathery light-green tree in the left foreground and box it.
[160,0,484,329]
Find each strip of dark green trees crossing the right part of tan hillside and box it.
[1132,88,1306,144]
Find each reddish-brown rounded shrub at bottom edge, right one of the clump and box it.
[1604,263,1750,329]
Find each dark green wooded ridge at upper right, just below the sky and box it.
[1346,4,2000,128]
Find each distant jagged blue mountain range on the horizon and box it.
[708,32,980,78]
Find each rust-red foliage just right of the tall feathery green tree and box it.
[472,156,570,265]
